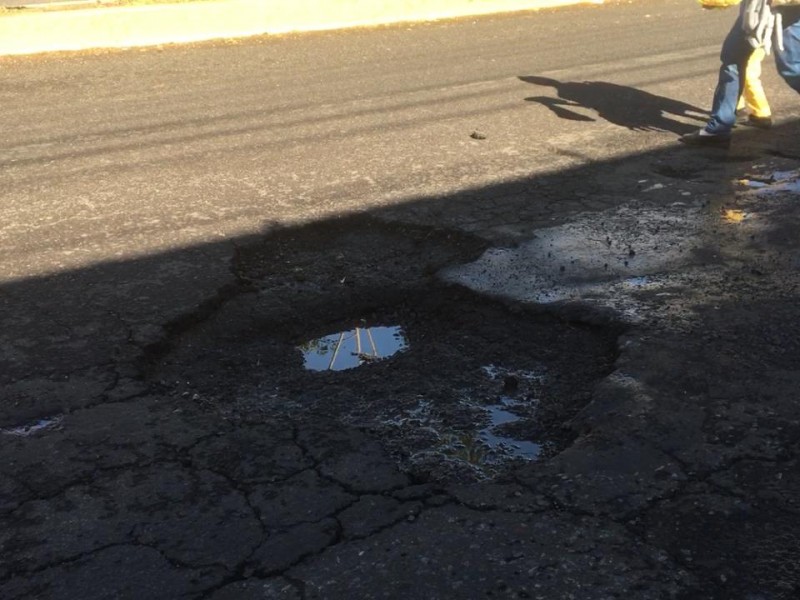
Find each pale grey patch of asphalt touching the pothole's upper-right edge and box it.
[443,203,703,304]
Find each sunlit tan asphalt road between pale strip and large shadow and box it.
[0,1,795,280]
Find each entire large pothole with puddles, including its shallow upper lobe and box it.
[151,220,618,481]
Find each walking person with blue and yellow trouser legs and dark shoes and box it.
[681,0,772,147]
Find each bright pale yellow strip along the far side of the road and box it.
[0,0,599,55]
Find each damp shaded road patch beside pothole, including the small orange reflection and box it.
[441,199,760,324]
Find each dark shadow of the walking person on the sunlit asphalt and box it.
[519,75,708,135]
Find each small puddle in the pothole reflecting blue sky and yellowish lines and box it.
[298,326,408,371]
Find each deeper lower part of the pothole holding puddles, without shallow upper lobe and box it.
[158,285,618,481]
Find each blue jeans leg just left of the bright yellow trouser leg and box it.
[705,16,752,135]
